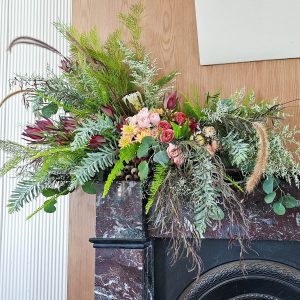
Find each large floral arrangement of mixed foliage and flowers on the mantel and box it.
[0,4,300,269]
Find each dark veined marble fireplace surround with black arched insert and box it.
[90,182,300,300]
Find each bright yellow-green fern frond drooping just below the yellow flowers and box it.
[102,143,139,198]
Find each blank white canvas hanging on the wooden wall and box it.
[195,0,300,65]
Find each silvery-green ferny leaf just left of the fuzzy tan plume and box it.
[222,131,249,168]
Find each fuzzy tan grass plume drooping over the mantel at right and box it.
[246,122,269,193]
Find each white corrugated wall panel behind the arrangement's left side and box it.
[0,0,71,300]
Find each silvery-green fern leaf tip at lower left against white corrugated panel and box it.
[7,179,43,213]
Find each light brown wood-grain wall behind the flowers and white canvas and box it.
[69,0,300,300]
